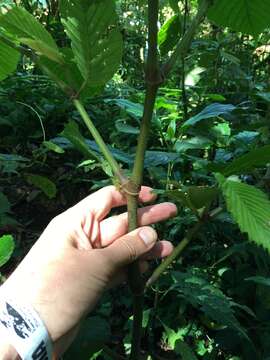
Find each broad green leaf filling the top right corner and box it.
[208,0,270,35]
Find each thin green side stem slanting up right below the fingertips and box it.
[146,221,203,287]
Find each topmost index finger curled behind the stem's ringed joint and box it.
[75,186,156,220]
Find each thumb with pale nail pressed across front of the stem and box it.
[103,226,158,268]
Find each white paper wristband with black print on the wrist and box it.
[0,291,52,360]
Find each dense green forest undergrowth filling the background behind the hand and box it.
[0,0,270,360]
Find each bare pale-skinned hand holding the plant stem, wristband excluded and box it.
[0,186,177,360]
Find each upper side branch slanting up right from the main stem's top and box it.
[162,0,213,78]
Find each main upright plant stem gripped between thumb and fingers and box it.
[127,0,161,360]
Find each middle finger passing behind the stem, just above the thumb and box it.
[100,203,177,247]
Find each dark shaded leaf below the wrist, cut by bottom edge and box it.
[64,316,111,360]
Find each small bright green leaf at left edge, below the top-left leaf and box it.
[0,40,20,81]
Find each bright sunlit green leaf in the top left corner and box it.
[0,6,63,63]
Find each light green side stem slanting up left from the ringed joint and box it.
[73,99,124,183]
